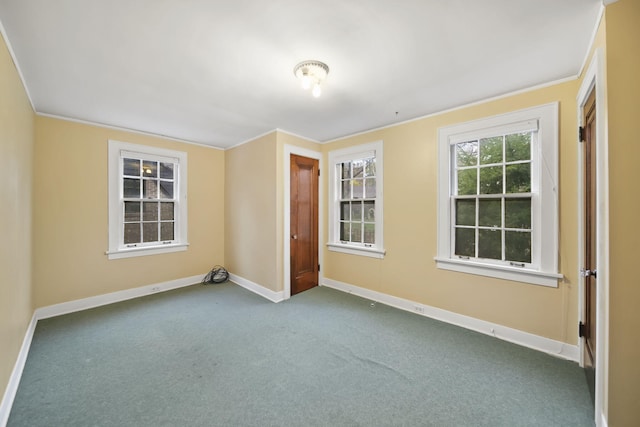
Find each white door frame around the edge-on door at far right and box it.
[576,48,609,425]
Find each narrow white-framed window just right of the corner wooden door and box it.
[328,141,385,258]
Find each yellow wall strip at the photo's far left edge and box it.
[0,36,34,404]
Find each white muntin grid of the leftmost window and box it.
[119,157,179,248]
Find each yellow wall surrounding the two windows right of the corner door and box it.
[323,81,578,344]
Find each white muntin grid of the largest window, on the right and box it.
[450,131,537,267]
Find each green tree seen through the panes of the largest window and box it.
[453,132,533,263]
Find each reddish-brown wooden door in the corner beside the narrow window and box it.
[290,154,319,295]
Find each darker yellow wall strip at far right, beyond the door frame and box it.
[606,0,640,427]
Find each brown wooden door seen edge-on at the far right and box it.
[582,89,597,400]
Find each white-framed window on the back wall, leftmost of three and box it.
[108,141,187,259]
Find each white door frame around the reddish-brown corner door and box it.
[282,144,326,299]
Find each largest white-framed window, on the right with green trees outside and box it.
[436,104,561,286]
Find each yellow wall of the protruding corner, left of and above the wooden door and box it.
[225,131,320,292]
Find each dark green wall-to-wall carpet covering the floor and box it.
[8,283,594,427]
